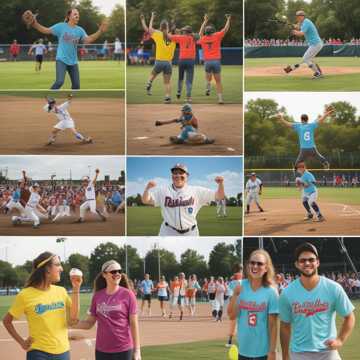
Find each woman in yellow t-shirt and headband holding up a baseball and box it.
[3,252,82,360]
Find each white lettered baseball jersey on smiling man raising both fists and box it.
[150,184,215,230]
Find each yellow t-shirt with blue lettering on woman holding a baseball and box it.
[9,285,71,354]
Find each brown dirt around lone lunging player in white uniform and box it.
[0,95,125,155]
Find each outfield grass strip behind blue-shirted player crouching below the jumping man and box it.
[262,184,360,205]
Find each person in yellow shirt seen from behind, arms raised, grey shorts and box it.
[140,12,176,104]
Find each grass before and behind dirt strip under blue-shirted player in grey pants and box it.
[245,57,360,91]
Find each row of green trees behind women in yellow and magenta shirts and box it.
[0,240,242,288]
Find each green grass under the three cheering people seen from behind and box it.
[126,65,242,104]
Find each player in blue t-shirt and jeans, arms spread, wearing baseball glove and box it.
[23,9,108,90]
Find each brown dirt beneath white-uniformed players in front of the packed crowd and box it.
[0,213,125,236]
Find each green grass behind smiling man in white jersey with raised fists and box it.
[127,206,242,236]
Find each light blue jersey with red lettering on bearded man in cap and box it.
[279,276,354,352]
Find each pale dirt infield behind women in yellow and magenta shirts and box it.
[0,301,229,360]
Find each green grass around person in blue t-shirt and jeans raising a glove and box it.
[0,61,125,90]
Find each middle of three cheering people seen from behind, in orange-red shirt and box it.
[167,25,199,103]
